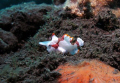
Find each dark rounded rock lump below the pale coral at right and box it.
[95,9,119,31]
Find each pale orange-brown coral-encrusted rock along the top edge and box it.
[63,0,120,17]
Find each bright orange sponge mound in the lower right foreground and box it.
[55,60,120,83]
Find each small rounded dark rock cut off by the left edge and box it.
[0,29,18,53]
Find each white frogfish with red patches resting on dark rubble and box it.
[39,33,84,55]
